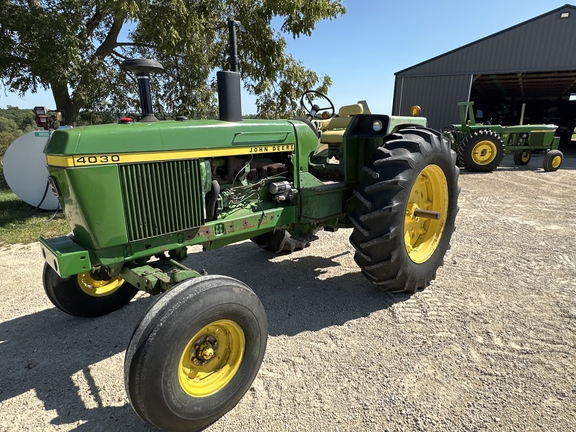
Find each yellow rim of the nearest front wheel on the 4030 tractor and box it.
[178,320,246,397]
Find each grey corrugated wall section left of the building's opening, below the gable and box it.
[392,75,472,129]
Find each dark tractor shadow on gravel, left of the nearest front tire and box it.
[0,298,155,431]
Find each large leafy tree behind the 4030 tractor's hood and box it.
[0,0,345,124]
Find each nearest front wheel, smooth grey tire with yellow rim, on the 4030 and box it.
[124,275,268,431]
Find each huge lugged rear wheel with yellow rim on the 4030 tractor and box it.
[350,127,460,292]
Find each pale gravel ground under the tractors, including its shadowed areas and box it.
[0,149,576,432]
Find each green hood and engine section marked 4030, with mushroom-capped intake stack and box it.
[41,50,318,277]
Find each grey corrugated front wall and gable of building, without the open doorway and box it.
[392,5,576,129]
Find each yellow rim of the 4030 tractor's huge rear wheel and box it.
[404,165,448,264]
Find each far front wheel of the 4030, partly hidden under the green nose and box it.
[42,263,138,318]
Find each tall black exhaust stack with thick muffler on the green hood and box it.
[216,20,245,122]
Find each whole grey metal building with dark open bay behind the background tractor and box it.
[392,4,576,142]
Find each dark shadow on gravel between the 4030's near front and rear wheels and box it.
[186,240,409,336]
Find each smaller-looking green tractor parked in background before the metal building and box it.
[443,102,564,172]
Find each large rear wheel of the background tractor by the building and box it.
[458,130,505,172]
